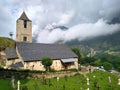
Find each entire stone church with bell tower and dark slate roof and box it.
[5,12,78,71]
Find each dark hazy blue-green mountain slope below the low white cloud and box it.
[66,30,120,51]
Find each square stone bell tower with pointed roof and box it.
[16,12,32,43]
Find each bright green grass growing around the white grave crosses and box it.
[0,71,120,90]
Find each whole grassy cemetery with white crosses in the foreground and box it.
[0,71,120,90]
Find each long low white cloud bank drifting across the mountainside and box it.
[37,19,120,43]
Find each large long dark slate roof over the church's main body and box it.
[16,42,77,61]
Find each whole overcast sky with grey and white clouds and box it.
[0,0,120,43]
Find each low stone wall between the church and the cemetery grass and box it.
[0,69,78,79]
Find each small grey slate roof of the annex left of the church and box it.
[5,48,18,60]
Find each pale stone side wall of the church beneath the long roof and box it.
[24,58,78,71]
